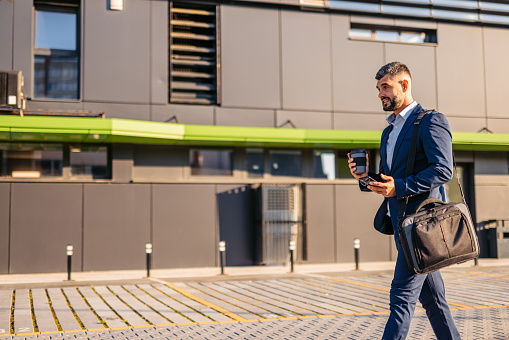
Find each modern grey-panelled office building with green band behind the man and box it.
[0,0,509,273]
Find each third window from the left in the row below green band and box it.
[189,149,233,176]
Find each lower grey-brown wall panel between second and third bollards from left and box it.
[152,184,214,268]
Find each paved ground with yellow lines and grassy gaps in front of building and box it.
[0,266,509,340]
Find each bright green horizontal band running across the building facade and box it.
[0,115,509,151]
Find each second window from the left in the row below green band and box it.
[69,145,111,179]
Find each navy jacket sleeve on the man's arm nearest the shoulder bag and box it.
[394,112,453,199]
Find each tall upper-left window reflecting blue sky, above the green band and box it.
[34,0,80,100]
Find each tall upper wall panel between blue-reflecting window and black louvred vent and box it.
[83,0,152,103]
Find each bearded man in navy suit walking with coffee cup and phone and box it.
[348,62,461,340]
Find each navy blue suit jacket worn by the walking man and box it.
[365,105,453,239]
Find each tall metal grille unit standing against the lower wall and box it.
[258,184,302,264]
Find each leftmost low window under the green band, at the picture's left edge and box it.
[0,143,63,178]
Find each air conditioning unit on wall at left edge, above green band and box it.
[0,71,25,110]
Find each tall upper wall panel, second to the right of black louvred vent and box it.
[281,10,332,111]
